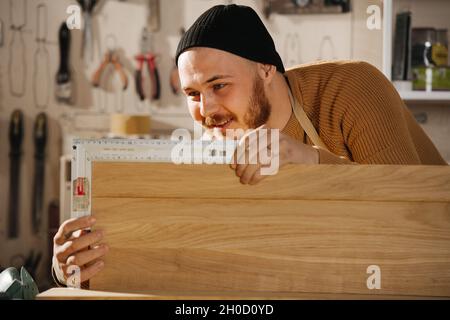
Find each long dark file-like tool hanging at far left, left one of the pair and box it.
[8,110,23,239]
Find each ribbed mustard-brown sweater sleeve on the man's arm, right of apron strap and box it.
[332,62,420,164]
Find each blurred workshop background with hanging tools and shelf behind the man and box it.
[0,0,450,290]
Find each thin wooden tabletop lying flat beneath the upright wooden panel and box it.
[36,288,442,300]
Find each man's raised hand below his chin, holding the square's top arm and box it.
[231,126,319,185]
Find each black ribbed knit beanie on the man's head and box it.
[175,4,284,73]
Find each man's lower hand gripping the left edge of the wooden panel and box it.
[53,216,108,283]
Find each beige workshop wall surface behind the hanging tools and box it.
[0,0,450,286]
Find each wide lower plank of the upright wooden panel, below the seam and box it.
[91,198,450,296]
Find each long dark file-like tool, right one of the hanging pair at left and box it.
[31,112,47,234]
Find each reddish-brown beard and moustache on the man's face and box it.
[203,75,272,129]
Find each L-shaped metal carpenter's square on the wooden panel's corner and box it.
[71,139,237,218]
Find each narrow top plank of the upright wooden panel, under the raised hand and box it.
[92,162,450,202]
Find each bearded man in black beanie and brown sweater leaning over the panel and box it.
[54,5,446,283]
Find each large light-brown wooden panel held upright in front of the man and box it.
[91,163,450,297]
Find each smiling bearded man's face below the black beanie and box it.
[178,48,271,135]
